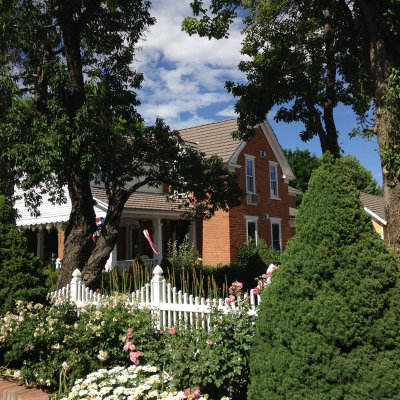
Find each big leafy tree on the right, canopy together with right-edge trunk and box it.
[183,0,400,254]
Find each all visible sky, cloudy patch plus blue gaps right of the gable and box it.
[133,0,382,184]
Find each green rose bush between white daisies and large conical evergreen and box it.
[159,309,254,399]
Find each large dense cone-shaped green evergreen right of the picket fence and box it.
[248,159,400,400]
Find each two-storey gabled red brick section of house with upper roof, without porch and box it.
[180,119,299,265]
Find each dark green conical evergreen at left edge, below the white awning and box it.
[0,196,47,315]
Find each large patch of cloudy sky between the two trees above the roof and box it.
[134,0,247,128]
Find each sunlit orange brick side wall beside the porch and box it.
[203,211,231,265]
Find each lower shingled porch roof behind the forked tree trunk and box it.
[91,187,183,213]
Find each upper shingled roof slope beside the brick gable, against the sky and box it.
[179,118,242,162]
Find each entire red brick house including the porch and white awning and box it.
[16,119,299,267]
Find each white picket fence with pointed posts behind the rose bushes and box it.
[48,265,261,330]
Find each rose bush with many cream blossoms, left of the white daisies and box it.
[0,296,159,388]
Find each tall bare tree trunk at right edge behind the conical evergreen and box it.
[357,0,400,257]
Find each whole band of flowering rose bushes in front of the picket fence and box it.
[0,295,254,400]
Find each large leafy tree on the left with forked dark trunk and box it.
[0,0,240,287]
